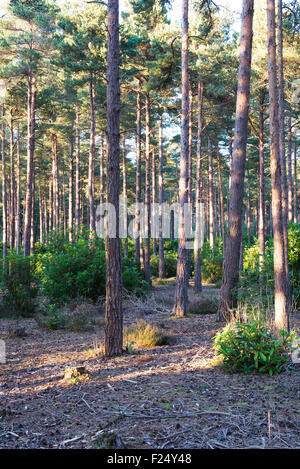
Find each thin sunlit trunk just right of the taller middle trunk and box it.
[194,81,203,292]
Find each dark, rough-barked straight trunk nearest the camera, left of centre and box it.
[105,0,123,356]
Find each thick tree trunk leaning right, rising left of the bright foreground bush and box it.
[219,0,253,321]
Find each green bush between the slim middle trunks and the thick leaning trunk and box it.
[200,239,223,283]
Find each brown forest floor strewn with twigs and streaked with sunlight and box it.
[0,285,300,449]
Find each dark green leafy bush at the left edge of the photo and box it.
[1,253,37,317]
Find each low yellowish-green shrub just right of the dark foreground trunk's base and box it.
[124,320,169,351]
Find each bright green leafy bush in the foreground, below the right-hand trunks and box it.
[214,321,294,375]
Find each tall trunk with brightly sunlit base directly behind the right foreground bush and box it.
[267,0,289,329]
